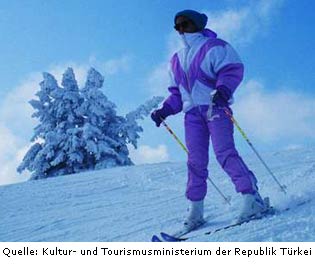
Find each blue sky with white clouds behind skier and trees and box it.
[0,0,315,184]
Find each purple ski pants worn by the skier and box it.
[185,106,257,201]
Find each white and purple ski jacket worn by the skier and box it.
[164,29,244,114]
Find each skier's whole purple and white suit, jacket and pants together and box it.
[163,29,257,201]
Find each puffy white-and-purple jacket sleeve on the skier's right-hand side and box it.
[211,43,244,97]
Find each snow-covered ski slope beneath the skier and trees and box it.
[0,148,315,241]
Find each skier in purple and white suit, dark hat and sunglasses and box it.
[151,10,267,230]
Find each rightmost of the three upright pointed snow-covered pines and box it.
[79,68,132,169]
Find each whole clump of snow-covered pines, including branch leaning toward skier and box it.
[18,68,163,179]
